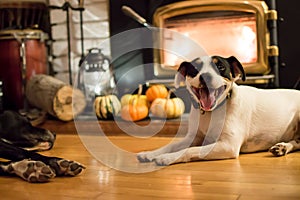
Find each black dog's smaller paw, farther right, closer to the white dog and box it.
[49,159,85,176]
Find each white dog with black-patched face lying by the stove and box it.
[137,56,300,166]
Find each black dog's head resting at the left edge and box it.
[0,111,55,151]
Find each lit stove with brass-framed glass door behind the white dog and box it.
[149,0,279,86]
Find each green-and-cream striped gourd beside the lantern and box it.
[94,94,121,119]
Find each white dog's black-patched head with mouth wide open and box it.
[175,56,246,111]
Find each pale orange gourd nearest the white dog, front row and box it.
[150,90,185,119]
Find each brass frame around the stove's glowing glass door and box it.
[153,0,279,84]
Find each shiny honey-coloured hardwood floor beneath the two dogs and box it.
[0,120,300,200]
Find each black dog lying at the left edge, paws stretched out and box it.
[0,111,85,183]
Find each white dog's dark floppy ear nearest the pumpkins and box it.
[174,58,198,88]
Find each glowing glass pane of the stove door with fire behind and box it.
[162,11,257,67]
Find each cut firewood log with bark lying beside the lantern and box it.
[25,74,86,121]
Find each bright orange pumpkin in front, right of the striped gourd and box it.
[121,85,149,121]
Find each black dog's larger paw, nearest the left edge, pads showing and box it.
[7,159,55,183]
